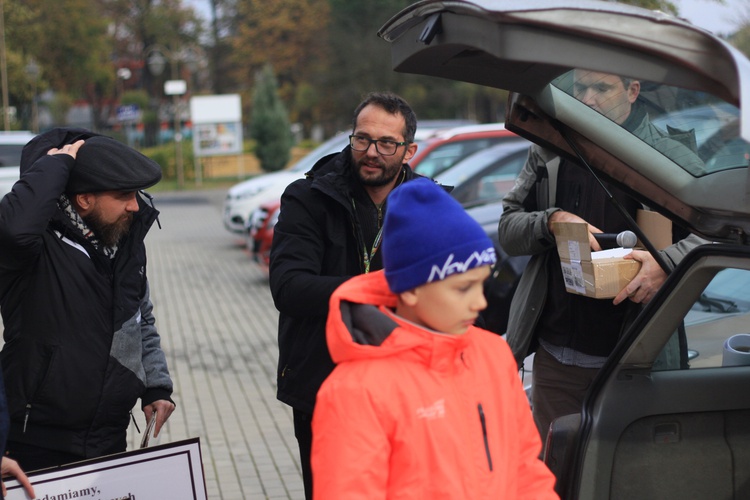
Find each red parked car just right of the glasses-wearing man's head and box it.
[409,123,518,177]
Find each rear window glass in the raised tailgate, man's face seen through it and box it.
[553,69,750,177]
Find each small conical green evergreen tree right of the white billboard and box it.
[250,64,292,172]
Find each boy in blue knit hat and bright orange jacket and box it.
[312,179,557,500]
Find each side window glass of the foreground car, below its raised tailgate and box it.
[654,268,750,370]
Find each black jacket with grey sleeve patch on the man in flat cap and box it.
[0,141,172,457]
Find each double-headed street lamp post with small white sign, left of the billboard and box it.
[146,46,195,189]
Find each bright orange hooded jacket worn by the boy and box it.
[312,271,558,500]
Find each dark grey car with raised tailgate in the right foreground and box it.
[379,0,750,500]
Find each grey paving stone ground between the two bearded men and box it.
[128,190,304,500]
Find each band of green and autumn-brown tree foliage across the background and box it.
[3,0,750,158]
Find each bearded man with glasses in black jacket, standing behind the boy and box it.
[270,93,424,499]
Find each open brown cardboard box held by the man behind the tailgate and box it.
[553,210,672,299]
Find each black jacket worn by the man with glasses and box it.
[270,146,424,413]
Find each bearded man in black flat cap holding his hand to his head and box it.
[0,128,175,471]
